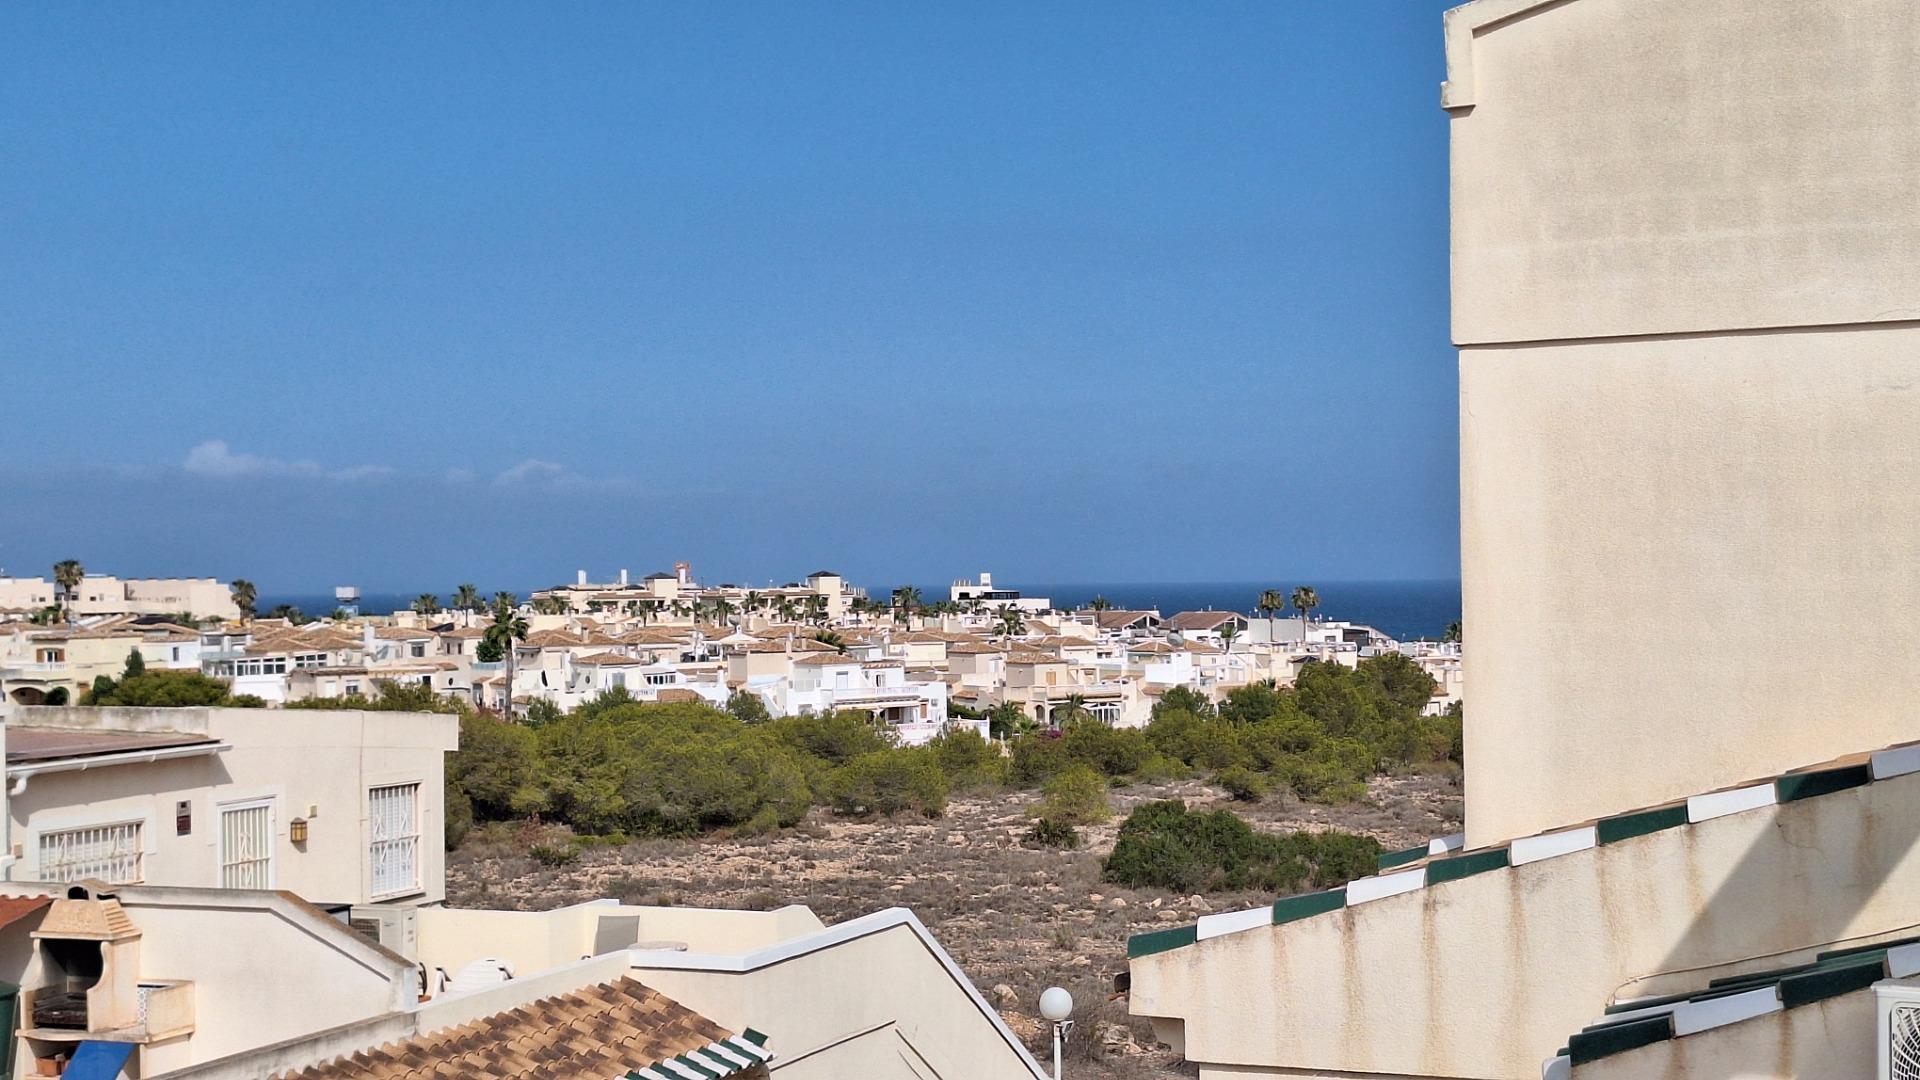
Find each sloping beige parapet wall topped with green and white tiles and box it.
[1131,748,1920,1078]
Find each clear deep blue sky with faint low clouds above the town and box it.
[0,0,1459,592]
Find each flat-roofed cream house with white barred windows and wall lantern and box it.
[0,707,459,907]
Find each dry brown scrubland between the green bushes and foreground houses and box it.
[447,774,1461,1080]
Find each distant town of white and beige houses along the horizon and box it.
[0,561,1463,734]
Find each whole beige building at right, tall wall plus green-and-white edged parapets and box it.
[1129,0,1920,1080]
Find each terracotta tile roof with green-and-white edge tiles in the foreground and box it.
[286,978,770,1080]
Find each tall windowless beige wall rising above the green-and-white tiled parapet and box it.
[1446,0,1920,844]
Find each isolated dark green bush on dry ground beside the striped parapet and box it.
[1100,799,1380,892]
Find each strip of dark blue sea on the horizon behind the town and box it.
[259,580,1459,638]
